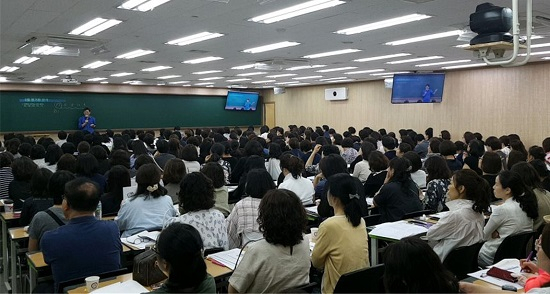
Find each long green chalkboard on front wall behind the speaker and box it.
[0,91,262,132]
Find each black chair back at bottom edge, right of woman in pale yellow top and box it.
[334,264,386,293]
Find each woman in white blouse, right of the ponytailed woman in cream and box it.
[478,171,538,266]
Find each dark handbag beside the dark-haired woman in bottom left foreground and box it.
[133,249,168,286]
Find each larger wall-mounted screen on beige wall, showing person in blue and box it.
[391,73,445,104]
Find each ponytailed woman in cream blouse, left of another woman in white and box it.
[426,169,491,261]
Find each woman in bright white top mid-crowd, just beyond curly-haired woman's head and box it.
[279,153,315,205]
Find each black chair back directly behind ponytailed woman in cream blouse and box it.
[443,242,483,280]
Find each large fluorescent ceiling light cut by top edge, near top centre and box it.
[248,0,346,24]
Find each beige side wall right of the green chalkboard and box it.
[264,63,550,146]
